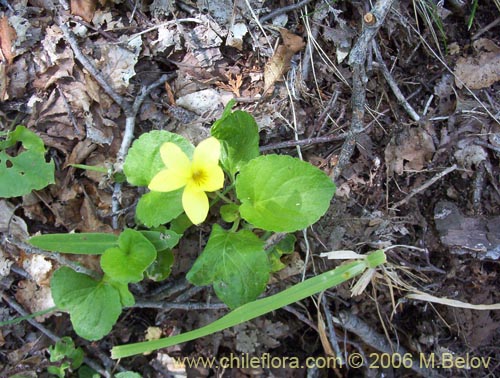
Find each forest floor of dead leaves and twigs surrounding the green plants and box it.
[0,0,500,377]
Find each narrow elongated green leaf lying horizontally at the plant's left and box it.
[29,232,118,255]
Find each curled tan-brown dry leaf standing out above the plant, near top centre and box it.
[264,28,305,92]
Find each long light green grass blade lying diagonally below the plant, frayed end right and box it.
[111,250,385,358]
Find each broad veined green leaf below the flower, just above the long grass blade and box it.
[186,224,270,308]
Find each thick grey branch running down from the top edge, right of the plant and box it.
[330,0,394,182]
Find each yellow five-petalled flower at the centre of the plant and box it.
[148,137,224,224]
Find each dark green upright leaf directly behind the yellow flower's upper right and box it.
[210,110,259,177]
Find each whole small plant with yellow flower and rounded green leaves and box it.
[30,104,384,354]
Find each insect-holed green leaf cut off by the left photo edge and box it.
[0,126,54,198]
